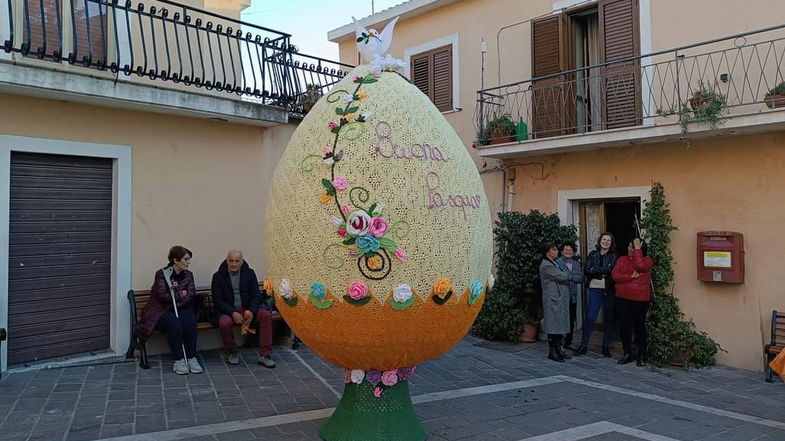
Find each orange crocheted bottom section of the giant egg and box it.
[273,283,487,370]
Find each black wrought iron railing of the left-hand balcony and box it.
[0,0,352,112]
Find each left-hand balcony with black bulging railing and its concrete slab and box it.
[0,0,352,122]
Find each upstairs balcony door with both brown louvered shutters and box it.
[532,0,641,138]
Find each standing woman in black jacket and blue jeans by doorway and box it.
[575,233,616,357]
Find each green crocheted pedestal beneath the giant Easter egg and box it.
[319,381,426,441]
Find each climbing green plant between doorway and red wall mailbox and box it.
[641,182,720,368]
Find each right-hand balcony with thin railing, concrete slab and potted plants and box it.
[475,25,785,158]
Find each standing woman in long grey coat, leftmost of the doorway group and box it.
[540,242,572,362]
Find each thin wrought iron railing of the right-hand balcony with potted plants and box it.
[475,25,785,145]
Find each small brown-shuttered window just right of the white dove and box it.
[410,45,453,112]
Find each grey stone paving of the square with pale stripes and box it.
[0,337,785,441]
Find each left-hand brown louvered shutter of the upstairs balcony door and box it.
[532,14,564,138]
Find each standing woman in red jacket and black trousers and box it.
[611,238,654,366]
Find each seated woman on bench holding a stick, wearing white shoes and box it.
[136,245,203,375]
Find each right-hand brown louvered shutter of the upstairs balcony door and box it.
[598,0,641,129]
